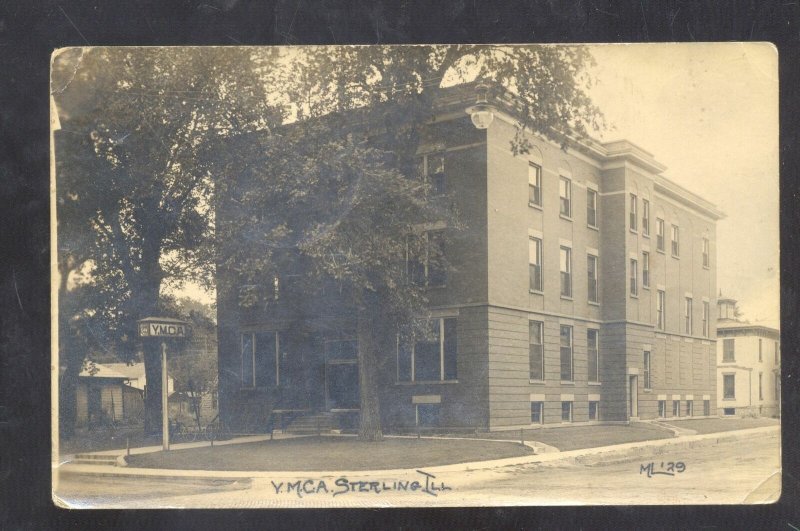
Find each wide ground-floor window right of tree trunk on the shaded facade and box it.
[397,317,458,382]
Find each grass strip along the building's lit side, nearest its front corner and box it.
[456,424,672,452]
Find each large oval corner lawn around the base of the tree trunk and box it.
[128,437,532,471]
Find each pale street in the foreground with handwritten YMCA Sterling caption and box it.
[57,431,780,508]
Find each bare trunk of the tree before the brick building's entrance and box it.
[357,308,383,441]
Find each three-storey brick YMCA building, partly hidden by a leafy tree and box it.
[218,84,723,431]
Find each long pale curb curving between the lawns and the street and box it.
[54,425,781,481]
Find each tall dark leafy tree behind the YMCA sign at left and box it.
[52,48,282,431]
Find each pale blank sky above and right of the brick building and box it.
[172,43,780,328]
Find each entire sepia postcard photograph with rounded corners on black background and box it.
[50,42,781,509]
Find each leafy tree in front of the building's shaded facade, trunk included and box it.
[217,46,602,440]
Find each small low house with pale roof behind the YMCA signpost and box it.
[75,363,175,426]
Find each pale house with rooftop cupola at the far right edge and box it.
[717,296,781,416]
